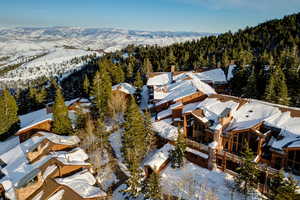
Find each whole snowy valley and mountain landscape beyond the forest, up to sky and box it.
[0,27,211,86]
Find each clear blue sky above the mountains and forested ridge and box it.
[0,0,300,32]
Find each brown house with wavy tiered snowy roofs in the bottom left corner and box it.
[0,132,106,200]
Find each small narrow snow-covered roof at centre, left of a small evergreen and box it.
[144,143,174,171]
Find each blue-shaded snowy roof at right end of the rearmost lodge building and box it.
[195,68,227,83]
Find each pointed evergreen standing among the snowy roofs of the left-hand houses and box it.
[52,88,72,135]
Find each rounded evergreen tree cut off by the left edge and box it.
[0,89,20,139]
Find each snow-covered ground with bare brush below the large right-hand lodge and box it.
[160,161,259,200]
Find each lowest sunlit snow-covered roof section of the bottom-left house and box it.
[55,170,106,198]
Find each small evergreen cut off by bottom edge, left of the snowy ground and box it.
[142,173,163,200]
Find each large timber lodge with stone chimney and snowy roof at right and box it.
[153,90,300,189]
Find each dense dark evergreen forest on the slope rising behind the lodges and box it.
[103,14,300,106]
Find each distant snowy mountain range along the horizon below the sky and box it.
[0,27,209,54]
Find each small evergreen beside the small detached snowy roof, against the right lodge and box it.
[170,128,186,168]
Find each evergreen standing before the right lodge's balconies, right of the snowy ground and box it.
[234,144,259,195]
